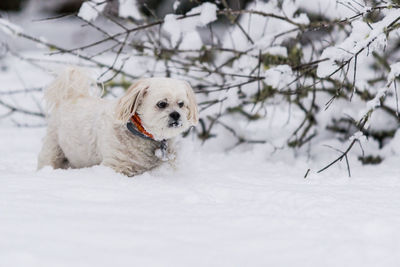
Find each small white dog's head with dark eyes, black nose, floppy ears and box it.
[116,78,199,140]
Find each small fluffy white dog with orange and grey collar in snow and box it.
[38,68,198,176]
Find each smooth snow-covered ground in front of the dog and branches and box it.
[0,127,400,267]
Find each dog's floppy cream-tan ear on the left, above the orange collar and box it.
[115,79,149,123]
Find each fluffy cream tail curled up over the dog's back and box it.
[44,67,98,113]
